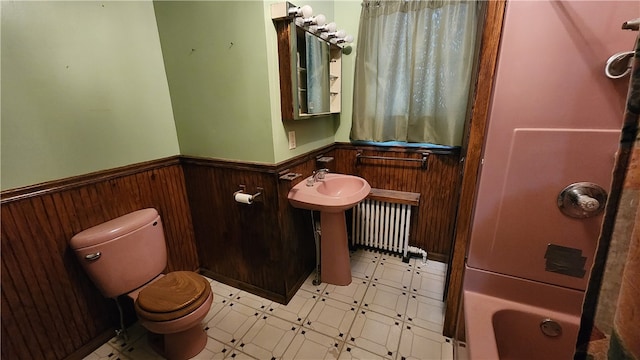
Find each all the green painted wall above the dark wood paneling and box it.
[0,0,360,190]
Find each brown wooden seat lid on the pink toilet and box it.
[135,271,211,321]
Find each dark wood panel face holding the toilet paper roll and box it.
[184,161,284,301]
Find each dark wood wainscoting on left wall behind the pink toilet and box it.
[1,157,198,359]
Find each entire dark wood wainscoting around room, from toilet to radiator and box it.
[0,144,468,359]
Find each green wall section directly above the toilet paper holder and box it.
[154,1,274,163]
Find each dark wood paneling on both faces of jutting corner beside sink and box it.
[183,150,322,303]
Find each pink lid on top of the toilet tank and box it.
[69,208,158,249]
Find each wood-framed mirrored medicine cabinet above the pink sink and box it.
[272,3,342,120]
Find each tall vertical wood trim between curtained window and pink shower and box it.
[443,0,506,337]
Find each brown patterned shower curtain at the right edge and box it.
[576,31,640,360]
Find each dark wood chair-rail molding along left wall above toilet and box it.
[0,155,180,204]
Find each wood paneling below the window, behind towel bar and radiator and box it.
[331,144,460,262]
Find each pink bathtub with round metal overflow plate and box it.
[463,267,584,360]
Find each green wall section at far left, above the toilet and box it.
[0,1,179,189]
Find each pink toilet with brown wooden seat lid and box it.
[70,209,213,360]
